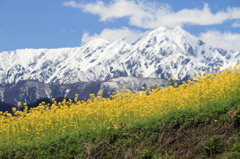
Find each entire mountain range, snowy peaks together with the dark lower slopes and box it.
[0,27,240,104]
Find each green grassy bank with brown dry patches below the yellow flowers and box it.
[0,98,240,159]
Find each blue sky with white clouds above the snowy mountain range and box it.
[0,0,240,52]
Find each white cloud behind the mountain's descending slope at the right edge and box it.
[199,30,240,51]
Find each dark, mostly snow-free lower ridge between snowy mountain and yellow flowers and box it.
[0,77,167,105]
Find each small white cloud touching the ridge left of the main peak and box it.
[82,27,141,44]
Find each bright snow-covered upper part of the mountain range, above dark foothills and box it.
[0,27,240,84]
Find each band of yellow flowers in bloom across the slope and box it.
[0,63,240,145]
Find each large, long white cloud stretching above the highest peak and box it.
[63,0,240,29]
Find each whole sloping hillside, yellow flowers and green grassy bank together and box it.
[0,63,240,158]
